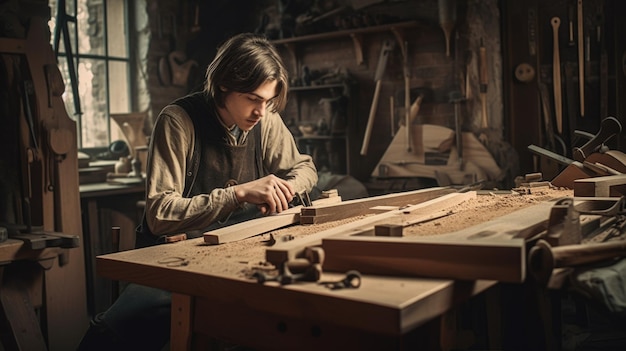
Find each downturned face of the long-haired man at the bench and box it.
[218,80,278,131]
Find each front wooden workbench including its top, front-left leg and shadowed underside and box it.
[97,231,496,350]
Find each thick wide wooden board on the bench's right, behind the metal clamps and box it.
[322,202,553,283]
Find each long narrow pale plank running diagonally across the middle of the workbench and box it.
[265,191,476,266]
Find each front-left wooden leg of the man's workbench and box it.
[170,293,193,350]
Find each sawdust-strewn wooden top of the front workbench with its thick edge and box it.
[97,236,495,335]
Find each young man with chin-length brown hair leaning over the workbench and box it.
[80,33,317,350]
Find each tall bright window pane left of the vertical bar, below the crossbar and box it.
[78,59,109,147]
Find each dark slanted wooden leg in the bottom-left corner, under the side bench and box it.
[0,266,48,350]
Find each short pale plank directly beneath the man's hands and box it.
[203,196,341,245]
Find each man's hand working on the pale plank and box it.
[234,174,295,215]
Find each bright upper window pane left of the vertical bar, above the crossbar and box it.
[76,0,105,55]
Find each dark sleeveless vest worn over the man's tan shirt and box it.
[136,92,266,247]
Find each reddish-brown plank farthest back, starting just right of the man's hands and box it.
[300,187,455,224]
